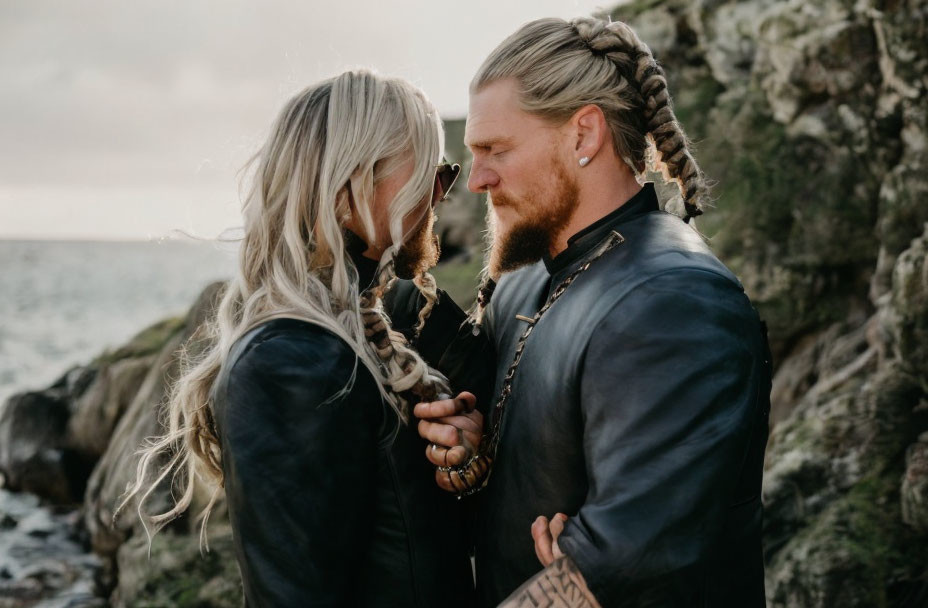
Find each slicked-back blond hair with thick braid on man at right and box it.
[470,17,708,222]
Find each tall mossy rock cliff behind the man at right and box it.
[611,0,928,608]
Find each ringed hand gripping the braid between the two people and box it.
[413,392,483,492]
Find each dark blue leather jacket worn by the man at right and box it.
[476,184,771,608]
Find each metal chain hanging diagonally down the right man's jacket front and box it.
[439,230,625,498]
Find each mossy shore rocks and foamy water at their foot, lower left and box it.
[0,283,241,607]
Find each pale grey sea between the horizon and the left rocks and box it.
[0,240,236,404]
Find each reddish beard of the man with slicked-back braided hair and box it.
[489,160,579,277]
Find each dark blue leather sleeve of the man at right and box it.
[546,270,769,606]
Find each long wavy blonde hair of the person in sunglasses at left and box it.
[113,71,447,548]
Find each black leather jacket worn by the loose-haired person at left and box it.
[214,234,486,607]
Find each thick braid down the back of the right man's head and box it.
[571,17,708,222]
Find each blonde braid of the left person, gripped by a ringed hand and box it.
[360,254,451,422]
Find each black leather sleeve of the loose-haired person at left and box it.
[220,328,383,607]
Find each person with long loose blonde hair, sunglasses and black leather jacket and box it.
[122,71,490,606]
